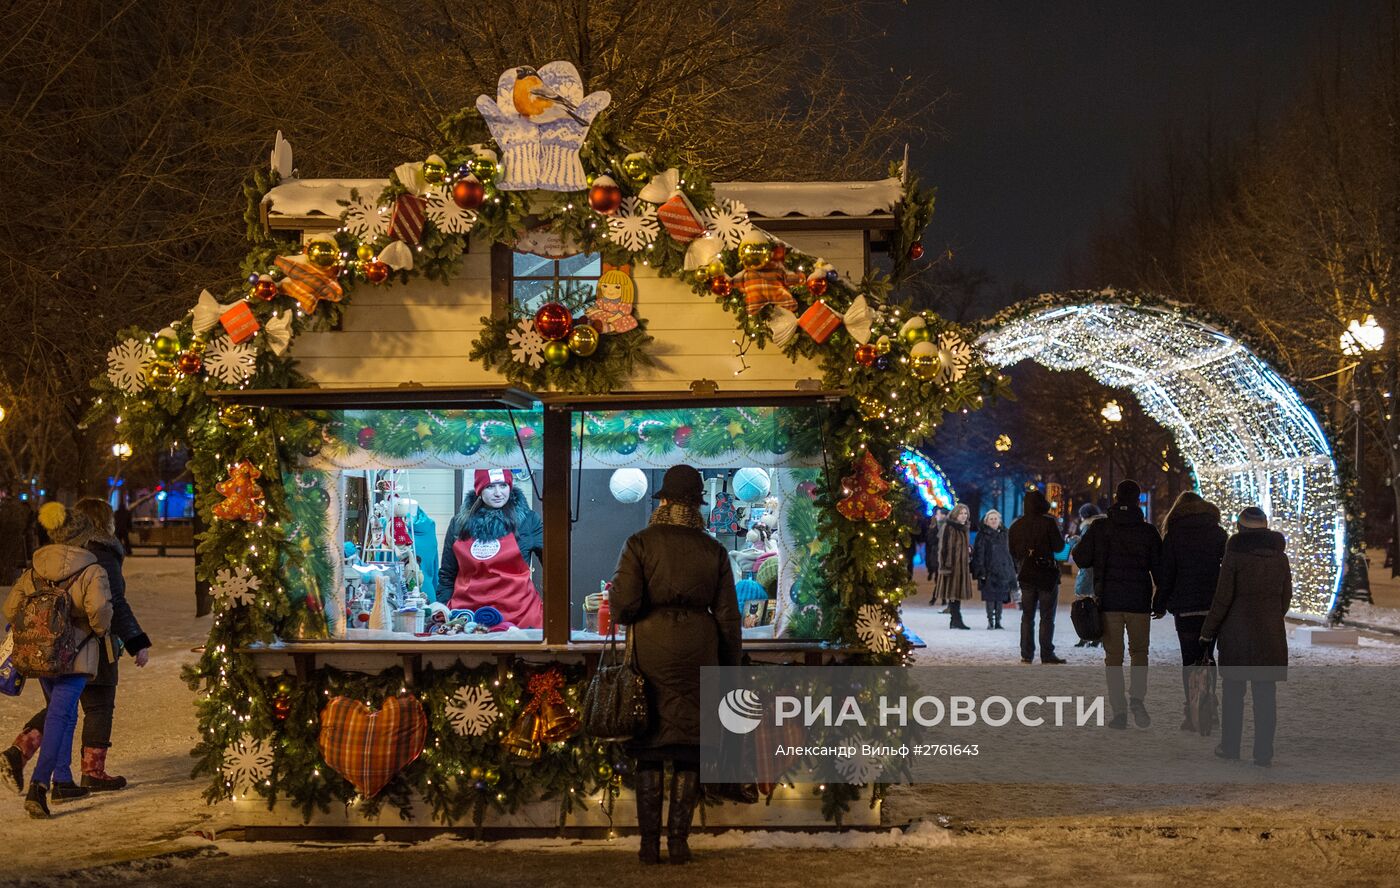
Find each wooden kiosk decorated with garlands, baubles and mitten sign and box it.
[98,62,1002,831]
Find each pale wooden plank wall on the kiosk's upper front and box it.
[293,231,865,386]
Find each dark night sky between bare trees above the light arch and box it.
[890,0,1378,299]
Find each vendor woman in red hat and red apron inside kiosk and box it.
[438,469,545,629]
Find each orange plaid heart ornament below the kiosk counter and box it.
[316,695,428,798]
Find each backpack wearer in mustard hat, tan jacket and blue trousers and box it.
[4,503,112,818]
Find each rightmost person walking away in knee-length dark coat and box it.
[1200,506,1294,768]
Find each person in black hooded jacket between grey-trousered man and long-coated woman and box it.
[1152,490,1226,731]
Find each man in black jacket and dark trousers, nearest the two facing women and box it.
[1008,490,1064,664]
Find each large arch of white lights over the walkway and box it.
[977,299,1345,613]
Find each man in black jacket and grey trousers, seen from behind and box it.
[1072,479,1162,730]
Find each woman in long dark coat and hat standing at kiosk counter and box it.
[610,465,741,863]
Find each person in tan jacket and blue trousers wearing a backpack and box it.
[4,503,112,818]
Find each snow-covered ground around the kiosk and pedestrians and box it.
[0,557,1400,888]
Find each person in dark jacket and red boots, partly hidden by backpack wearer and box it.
[0,497,151,793]
